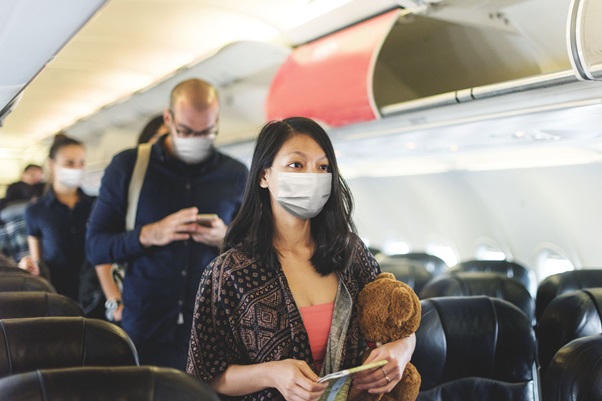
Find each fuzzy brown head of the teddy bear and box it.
[357,273,420,343]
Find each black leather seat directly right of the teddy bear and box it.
[412,296,539,401]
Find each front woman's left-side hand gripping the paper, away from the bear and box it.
[268,359,328,401]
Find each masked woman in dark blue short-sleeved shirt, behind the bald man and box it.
[20,134,94,301]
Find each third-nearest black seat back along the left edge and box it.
[0,291,84,319]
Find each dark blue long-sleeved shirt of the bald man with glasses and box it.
[87,136,248,342]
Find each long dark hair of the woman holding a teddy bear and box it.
[223,117,357,275]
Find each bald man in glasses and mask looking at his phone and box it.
[87,79,248,370]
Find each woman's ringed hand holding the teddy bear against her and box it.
[353,334,416,394]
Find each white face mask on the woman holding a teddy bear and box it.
[273,170,332,219]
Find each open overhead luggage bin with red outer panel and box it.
[266,0,570,127]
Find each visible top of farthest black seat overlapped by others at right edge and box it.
[535,269,602,321]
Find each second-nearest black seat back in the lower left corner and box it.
[0,317,138,377]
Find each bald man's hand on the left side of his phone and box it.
[140,207,199,248]
